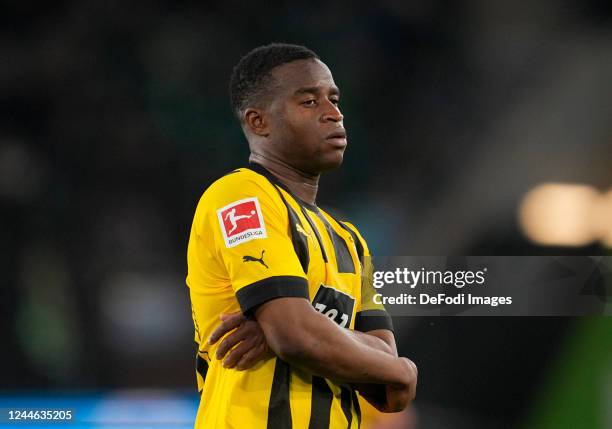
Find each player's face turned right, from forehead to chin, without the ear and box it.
[266,59,347,174]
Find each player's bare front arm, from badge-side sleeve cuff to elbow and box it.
[256,298,416,390]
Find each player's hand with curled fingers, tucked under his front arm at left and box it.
[208,312,270,371]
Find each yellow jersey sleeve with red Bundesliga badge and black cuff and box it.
[196,173,309,314]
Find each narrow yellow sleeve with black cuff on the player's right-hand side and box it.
[343,222,393,332]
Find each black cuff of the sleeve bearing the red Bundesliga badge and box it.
[236,276,309,315]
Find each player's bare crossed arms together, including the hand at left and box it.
[209,298,417,412]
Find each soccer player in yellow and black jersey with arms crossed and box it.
[187,44,417,429]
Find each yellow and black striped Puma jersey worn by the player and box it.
[187,164,392,429]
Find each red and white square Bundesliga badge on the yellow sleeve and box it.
[217,197,267,247]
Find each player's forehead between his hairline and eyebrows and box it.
[271,58,335,93]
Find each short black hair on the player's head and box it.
[229,43,319,120]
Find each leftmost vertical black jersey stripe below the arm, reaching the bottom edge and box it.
[267,358,292,429]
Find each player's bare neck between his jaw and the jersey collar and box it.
[249,153,321,205]
